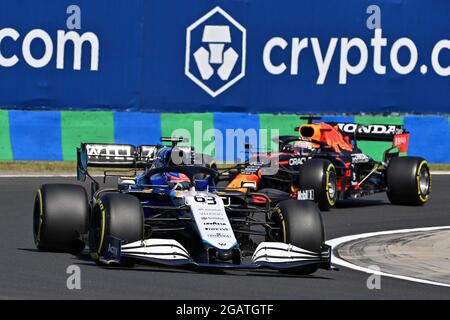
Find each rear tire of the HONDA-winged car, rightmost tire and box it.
[386,157,431,206]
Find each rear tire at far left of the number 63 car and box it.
[33,184,89,253]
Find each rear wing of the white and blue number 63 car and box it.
[77,143,162,181]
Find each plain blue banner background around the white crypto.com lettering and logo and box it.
[0,0,450,113]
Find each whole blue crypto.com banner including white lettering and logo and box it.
[0,0,450,113]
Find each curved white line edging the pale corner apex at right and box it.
[326,226,450,288]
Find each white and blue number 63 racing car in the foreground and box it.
[33,138,331,274]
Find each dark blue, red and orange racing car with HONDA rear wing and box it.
[228,117,431,210]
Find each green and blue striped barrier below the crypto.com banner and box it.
[0,110,450,163]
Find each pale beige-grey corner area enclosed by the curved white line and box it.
[334,229,450,286]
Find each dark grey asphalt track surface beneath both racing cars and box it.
[0,176,450,299]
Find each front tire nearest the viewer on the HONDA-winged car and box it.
[298,159,338,211]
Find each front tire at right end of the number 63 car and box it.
[272,199,325,274]
